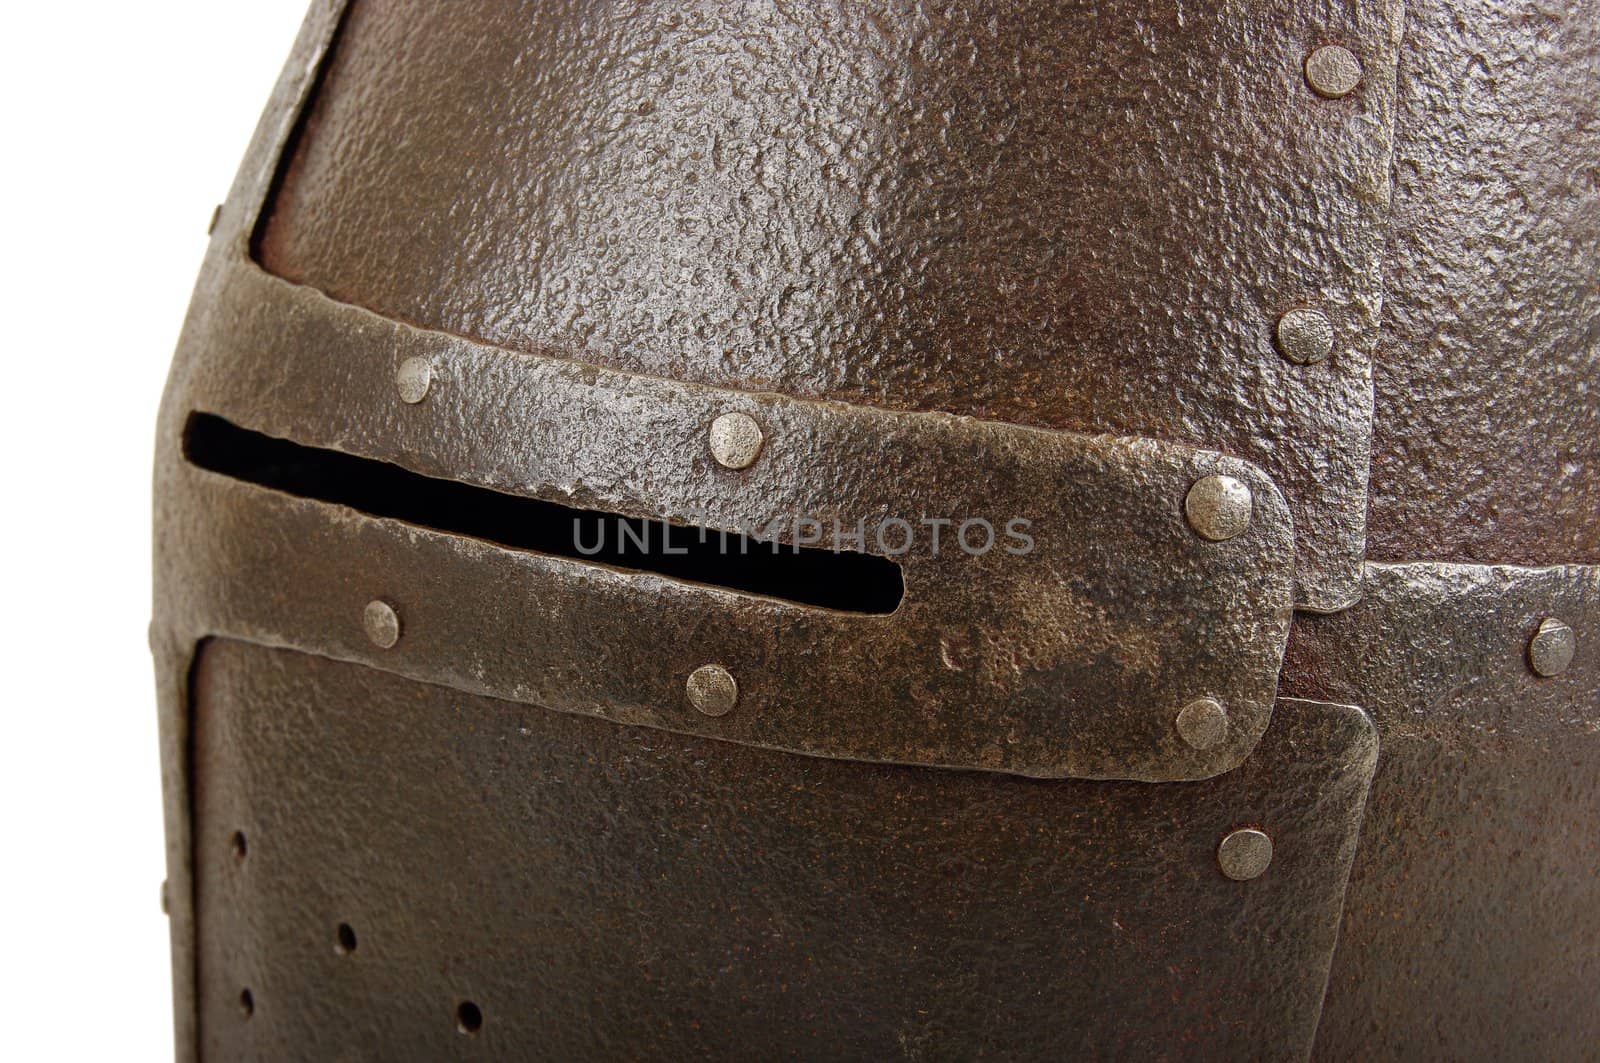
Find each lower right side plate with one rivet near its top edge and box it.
[1269,564,1600,1060]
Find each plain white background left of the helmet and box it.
[0,0,315,1061]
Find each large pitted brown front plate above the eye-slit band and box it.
[249,0,1400,610]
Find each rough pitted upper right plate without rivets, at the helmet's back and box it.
[1370,0,1600,565]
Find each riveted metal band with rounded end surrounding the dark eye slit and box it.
[158,261,1293,780]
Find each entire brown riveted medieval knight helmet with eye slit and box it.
[152,0,1600,1060]
